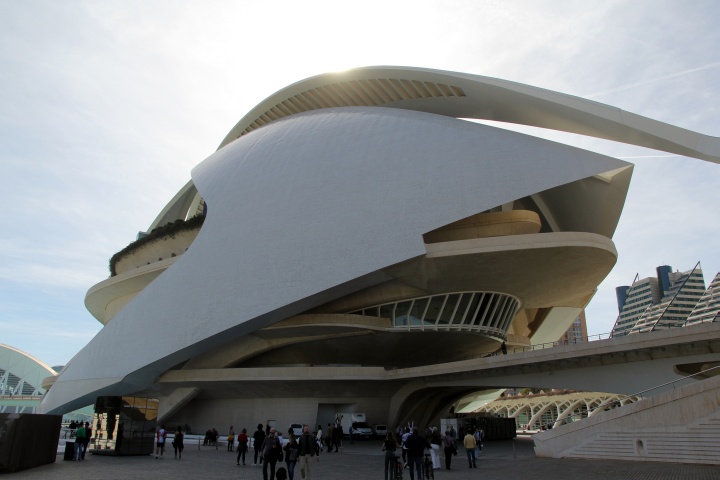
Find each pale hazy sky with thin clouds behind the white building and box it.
[0,0,720,365]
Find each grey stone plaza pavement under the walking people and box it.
[7,437,720,480]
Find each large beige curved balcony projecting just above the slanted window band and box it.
[316,232,617,313]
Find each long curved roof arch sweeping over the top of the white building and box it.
[218,66,720,163]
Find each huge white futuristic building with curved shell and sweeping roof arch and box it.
[41,67,720,428]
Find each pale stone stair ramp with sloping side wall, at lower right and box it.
[533,377,720,465]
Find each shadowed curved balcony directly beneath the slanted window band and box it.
[212,313,530,369]
